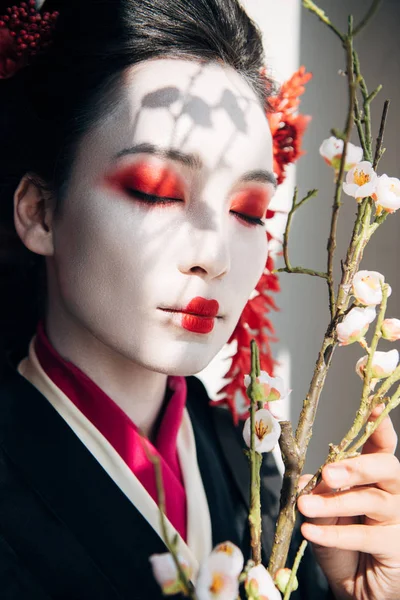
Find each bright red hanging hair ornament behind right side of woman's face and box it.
[216,67,312,423]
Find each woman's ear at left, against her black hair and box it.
[14,174,54,256]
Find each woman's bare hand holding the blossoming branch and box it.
[298,407,400,600]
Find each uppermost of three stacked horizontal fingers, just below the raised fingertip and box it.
[322,453,400,494]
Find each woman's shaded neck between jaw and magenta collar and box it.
[45,310,167,439]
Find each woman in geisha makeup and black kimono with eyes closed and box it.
[0,0,400,600]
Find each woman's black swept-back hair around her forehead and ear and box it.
[0,0,269,368]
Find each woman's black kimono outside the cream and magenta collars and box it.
[0,360,330,600]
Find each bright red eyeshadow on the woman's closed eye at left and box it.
[106,161,184,201]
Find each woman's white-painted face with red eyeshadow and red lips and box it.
[50,59,274,375]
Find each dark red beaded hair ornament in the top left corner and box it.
[0,0,59,79]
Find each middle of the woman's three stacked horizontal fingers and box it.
[298,487,400,524]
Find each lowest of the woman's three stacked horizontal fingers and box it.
[301,523,400,567]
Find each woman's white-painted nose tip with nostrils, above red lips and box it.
[178,221,231,280]
